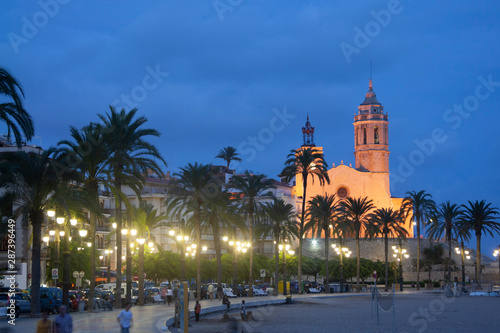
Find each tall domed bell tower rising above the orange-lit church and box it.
[354,78,389,173]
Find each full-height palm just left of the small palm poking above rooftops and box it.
[169,163,213,297]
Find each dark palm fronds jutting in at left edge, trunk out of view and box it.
[0,67,35,147]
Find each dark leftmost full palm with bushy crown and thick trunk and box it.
[0,148,69,316]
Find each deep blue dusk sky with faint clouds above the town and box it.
[0,0,500,252]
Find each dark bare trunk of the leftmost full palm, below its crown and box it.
[31,218,43,317]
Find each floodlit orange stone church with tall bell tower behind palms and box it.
[293,79,413,238]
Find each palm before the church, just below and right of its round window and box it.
[340,197,375,291]
